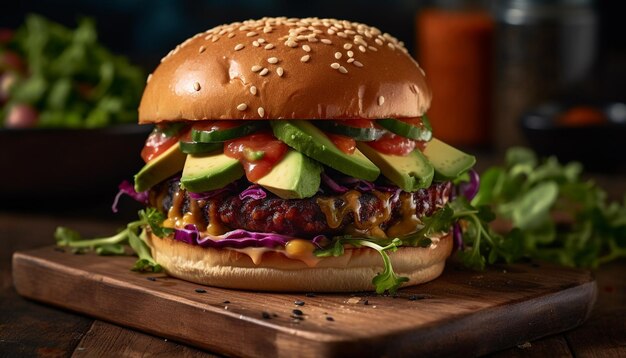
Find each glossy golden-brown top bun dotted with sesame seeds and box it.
[139,18,431,123]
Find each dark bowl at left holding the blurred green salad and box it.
[0,125,152,210]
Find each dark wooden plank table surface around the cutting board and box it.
[0,210,626,357]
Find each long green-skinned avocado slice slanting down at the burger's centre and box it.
[270,121,380,181]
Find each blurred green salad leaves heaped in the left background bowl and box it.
[0,15,146,128]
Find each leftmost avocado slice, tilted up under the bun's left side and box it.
[135,143,187,192]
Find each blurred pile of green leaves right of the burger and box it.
[466,148,626,268]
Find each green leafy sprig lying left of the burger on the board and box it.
[54,208,166,272]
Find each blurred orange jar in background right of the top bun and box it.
[417,9,494,146]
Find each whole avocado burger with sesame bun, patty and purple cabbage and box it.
[134,18,475,292]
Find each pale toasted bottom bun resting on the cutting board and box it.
[148,234,452,292]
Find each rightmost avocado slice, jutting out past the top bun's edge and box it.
[424,138,476,179]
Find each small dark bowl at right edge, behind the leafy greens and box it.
[521,102,626,173]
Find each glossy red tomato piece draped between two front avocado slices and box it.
[224,131,288,183]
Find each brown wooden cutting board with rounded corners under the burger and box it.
[13,247,597,357]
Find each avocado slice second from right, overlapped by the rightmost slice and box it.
[357,142,434,192]
